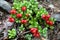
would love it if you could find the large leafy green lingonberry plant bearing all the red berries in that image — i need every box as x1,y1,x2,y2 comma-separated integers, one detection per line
9,0,55,40
